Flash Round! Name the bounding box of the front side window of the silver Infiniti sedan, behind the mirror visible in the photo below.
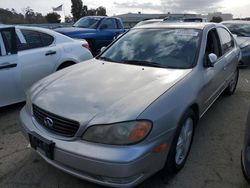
[205,29,221,62]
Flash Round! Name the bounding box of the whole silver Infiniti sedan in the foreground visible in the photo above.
[20,22,240,187]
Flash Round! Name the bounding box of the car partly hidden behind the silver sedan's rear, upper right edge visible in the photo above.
[222,20,250,67]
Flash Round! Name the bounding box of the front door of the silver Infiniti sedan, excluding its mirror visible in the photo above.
[201,28,226,112]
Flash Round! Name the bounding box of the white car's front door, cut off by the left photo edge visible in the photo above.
[0,27,25,107]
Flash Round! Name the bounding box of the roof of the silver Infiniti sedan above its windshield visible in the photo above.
[134,21,218,30]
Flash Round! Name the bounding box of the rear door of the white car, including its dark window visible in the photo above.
[17,28,60,91]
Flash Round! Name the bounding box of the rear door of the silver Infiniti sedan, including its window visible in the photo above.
[217,27,240,82]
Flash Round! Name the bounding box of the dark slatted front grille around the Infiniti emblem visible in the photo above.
[33,105,80,137]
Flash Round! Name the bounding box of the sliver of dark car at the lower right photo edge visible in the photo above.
[241,110,250,182]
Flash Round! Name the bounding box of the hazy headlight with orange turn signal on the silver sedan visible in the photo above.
[82,120,152,145]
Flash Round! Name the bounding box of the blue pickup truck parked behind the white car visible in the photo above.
[55,16,125,55]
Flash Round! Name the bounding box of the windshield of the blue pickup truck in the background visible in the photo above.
[73,17,101,29]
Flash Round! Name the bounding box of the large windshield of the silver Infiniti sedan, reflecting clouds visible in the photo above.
[99,29,200,69]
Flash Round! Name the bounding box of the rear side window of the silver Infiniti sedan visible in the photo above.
[217,28,234,54]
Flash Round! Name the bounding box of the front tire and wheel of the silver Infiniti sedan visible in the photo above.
[163,109,197,176]
